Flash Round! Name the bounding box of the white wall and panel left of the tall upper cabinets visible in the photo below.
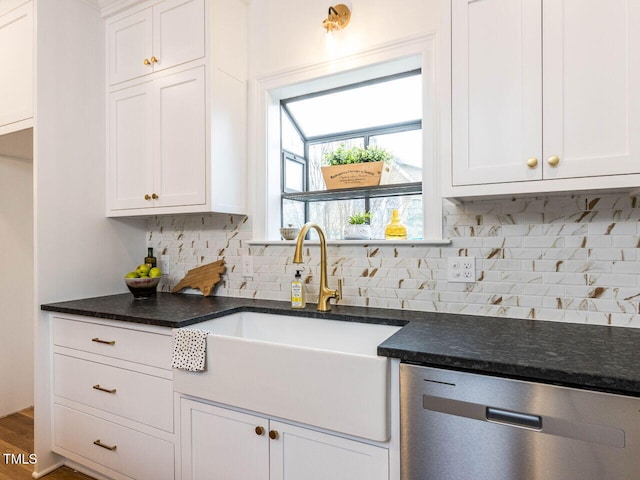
[34,0,146,472]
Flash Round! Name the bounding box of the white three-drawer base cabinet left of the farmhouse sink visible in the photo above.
[51,315,177,480]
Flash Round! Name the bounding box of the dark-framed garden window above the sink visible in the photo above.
[280,69,424,240]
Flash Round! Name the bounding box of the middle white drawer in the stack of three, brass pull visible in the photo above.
[54,354,173,432]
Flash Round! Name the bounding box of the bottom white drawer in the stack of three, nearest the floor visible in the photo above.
[53,405,175,480]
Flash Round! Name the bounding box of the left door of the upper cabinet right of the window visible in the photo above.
[451,0,542,185]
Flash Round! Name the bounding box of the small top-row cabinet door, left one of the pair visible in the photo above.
[107,9,153,85]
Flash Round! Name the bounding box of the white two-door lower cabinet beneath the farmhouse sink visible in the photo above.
[180,398,389,480]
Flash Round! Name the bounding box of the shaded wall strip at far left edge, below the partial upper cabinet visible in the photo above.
[0,153,33,417]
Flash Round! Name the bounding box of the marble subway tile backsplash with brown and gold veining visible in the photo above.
[147,193,640,327]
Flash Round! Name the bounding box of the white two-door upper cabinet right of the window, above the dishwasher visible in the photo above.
[443,0,640,197]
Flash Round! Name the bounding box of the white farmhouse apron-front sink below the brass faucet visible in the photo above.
[174,312,400,441]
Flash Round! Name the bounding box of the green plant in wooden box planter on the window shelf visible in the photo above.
[322,143,393,190]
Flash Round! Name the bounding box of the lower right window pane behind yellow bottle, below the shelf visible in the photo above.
[370,195,423,240]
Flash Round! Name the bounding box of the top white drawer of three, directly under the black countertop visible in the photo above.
[53,317,173,370]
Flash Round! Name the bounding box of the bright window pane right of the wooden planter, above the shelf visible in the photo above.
[369,130,422,183]
